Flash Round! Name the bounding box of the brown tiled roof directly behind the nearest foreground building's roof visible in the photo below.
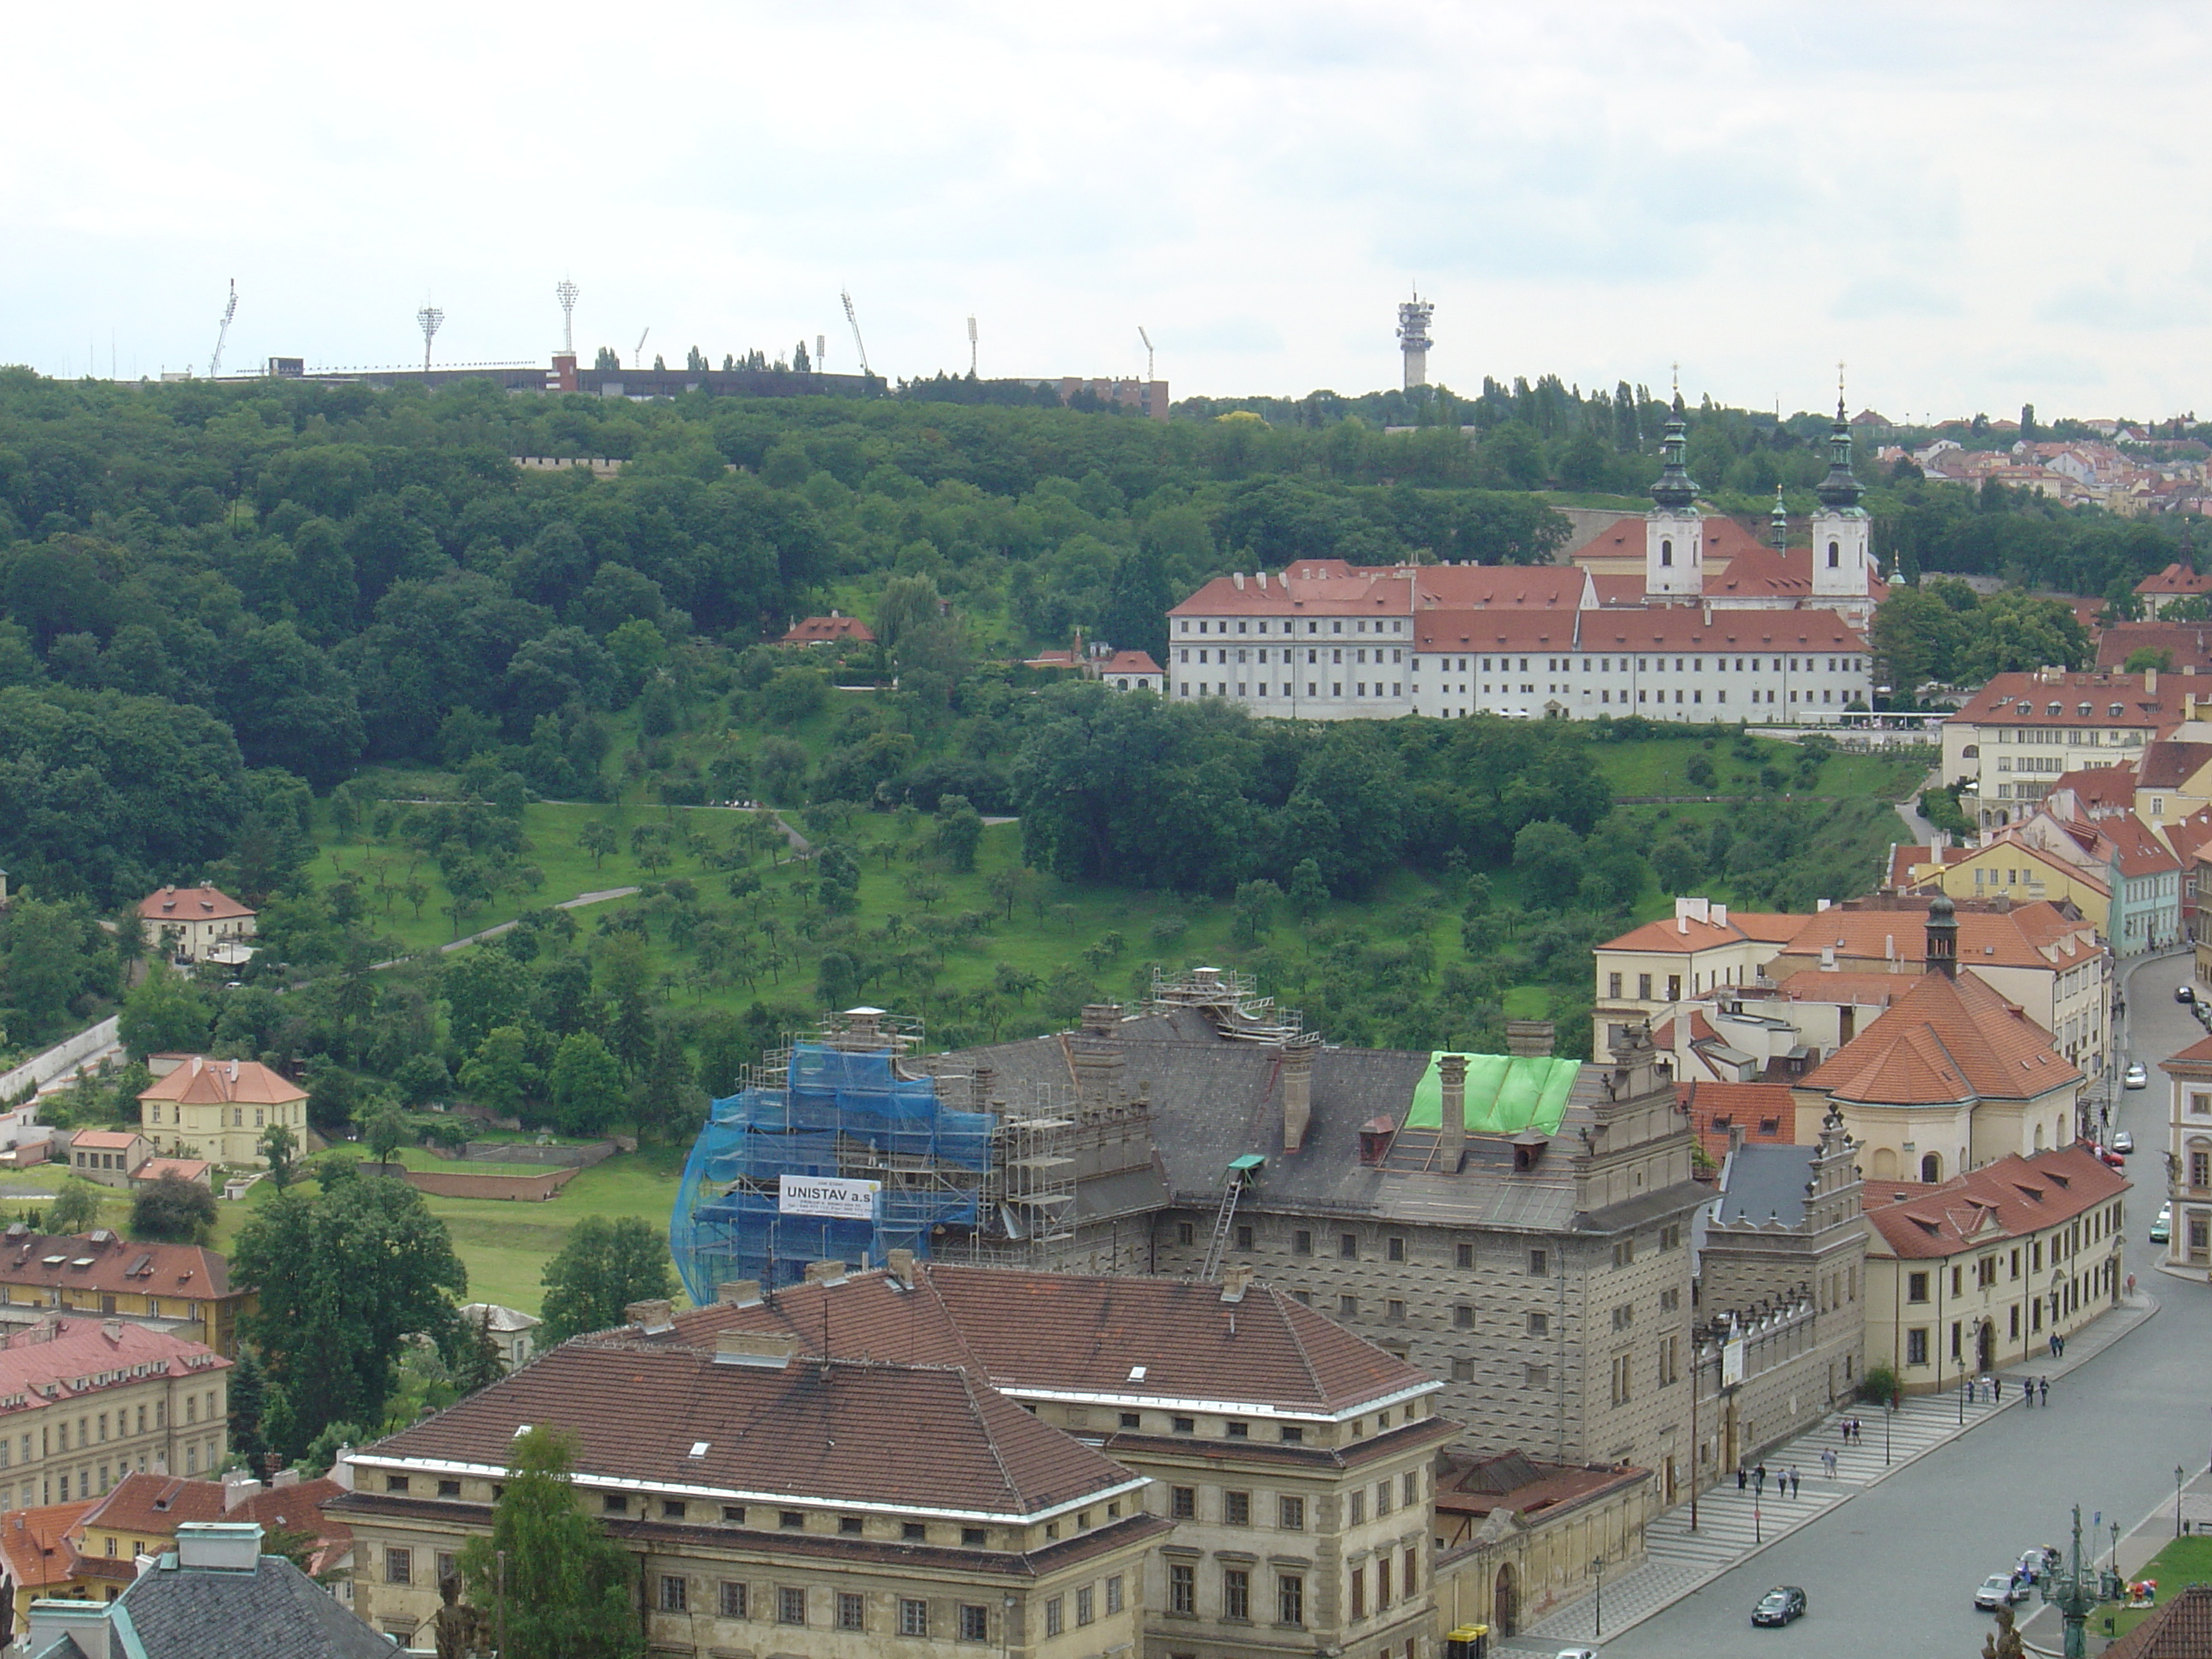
[614,1263,1434,1416]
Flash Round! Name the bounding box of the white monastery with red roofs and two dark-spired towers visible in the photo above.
[1166,399,1883,724]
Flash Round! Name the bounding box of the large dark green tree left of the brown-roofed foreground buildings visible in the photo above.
[230,1174,469,1458]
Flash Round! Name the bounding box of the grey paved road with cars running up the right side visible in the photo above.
[1575,958,2212,1659]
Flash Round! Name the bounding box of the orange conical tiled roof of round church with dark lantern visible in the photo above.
[1802,973,2081,1106]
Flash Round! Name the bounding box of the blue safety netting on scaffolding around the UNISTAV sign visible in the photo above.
[668,1042,993,1303]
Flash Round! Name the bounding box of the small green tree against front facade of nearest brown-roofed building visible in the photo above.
[460,1427,646,1659]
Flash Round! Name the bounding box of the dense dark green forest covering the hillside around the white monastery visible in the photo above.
[0,370,2179,1092]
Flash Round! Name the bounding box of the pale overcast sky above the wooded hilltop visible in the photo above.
[0,0,2212,418]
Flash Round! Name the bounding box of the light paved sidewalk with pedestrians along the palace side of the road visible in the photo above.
[1495,1289,2159,1655]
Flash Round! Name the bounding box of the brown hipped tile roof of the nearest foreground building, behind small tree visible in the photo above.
[360,1331,1132,1520]
